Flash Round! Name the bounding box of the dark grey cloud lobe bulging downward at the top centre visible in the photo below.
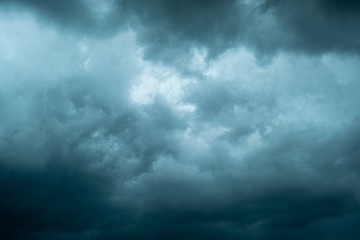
[118,0,248,62]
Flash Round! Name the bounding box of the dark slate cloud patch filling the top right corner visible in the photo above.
[266,0,360,54]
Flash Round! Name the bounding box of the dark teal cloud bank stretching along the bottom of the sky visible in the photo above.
[0,116,359,239]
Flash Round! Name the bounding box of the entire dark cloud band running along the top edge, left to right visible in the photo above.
[1,0,360,63]
